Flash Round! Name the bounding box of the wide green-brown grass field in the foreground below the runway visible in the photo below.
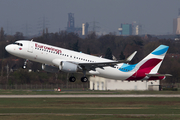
[0,98,180,120]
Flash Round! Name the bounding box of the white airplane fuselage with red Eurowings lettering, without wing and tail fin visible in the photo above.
[5,40,169,80]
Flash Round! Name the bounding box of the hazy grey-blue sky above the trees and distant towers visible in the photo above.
[0,0,180,35]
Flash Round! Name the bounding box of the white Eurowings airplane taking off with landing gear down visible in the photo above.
[5,40,171,82]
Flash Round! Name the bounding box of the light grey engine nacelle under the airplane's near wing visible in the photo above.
[59,61,78,73]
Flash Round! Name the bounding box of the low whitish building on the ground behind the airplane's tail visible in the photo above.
[89,76,160,91]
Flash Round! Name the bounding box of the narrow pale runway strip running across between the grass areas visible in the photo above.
[0,94,180,98]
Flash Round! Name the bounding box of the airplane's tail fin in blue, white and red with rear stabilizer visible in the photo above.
[127,45,169,80]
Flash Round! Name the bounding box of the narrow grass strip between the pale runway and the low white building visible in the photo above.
[0,89,180,95]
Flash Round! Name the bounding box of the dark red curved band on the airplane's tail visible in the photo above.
[127,58,162,80]
